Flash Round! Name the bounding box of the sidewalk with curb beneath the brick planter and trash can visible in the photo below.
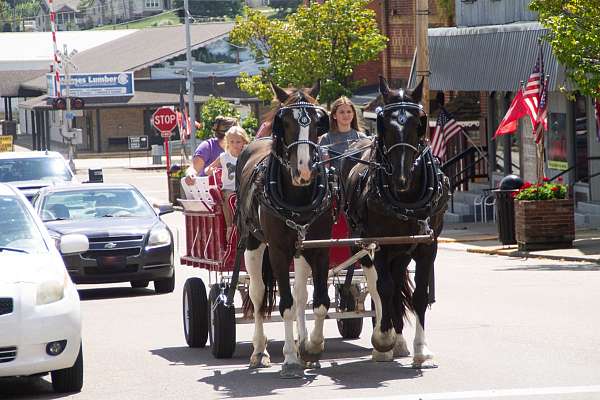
[439,223,600,264]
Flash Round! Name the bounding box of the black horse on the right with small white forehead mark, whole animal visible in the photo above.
[341,77,448,366]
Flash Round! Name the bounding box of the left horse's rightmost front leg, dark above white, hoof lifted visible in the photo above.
[299,249,330,367]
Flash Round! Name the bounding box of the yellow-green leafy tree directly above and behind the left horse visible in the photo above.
[230,0,387,103]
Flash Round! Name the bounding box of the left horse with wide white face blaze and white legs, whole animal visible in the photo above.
[236,83,333,378]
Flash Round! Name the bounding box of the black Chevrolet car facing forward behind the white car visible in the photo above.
[33,183,175,293]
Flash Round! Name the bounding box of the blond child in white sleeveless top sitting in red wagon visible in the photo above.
[204,125,250,239]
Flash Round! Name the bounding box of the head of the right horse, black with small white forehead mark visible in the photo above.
[377,76,427,193]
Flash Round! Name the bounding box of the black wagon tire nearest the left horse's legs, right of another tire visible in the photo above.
[208,284,236,358]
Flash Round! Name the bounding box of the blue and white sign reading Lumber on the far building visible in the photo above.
[46,72,134,98]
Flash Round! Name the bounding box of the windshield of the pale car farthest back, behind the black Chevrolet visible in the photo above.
[0,157,73,182]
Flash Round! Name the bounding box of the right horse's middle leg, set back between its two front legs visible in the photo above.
[392,254,412,357]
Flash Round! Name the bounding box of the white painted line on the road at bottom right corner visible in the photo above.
[344,385,600,400]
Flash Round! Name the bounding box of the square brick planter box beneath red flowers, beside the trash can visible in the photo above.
[515,199,575,251]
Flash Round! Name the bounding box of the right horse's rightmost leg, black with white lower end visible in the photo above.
[412,242,437,367]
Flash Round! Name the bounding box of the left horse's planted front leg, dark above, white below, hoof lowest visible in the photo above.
[269,246,304,378]
